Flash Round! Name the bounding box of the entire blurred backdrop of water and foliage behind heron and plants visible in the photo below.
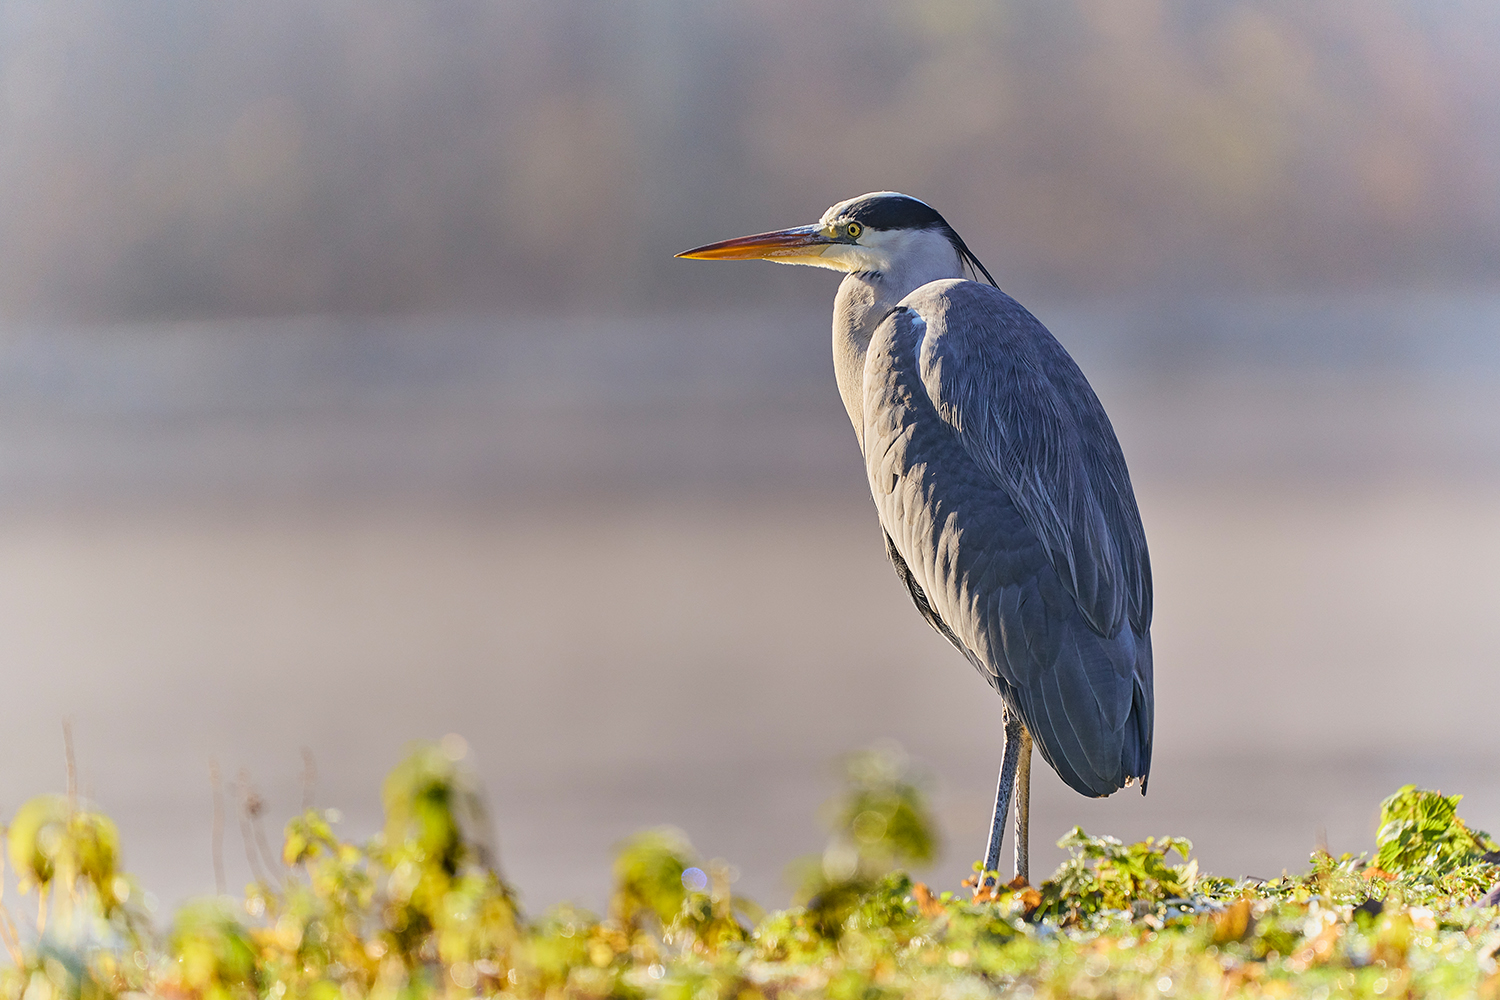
[0,0,1500,910]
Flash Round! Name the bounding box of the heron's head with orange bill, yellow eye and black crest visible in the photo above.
[678,190,995,285]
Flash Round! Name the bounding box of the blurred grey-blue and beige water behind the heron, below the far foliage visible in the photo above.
[0,295,1500,906]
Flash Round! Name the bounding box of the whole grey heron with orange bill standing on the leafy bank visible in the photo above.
[678,192,1155,886]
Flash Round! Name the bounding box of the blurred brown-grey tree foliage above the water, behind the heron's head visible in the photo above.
[0,0,1500,318]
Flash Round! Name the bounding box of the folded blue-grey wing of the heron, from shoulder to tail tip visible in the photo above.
[864,282,1154,795]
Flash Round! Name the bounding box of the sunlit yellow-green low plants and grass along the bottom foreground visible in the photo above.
[0,747,1500,1000]
